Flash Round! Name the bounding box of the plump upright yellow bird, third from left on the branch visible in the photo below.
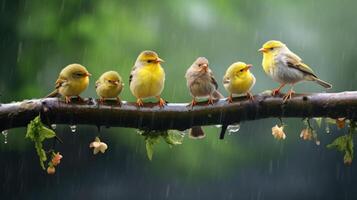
[129,51,166,107]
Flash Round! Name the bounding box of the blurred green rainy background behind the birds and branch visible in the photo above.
[0,0,357,199]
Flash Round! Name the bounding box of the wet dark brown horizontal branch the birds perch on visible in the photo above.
[0,92,357,130]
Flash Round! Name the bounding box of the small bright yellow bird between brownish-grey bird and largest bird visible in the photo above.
[223,62,255,103]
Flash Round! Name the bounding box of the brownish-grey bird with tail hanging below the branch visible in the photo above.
[185,57,224,138]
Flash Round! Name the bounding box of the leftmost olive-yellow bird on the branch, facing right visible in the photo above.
[46,64,91,103]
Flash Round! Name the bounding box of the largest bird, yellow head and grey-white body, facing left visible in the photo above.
[259,40,332,101]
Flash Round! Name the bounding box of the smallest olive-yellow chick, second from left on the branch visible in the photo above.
[95,71,124,104]
